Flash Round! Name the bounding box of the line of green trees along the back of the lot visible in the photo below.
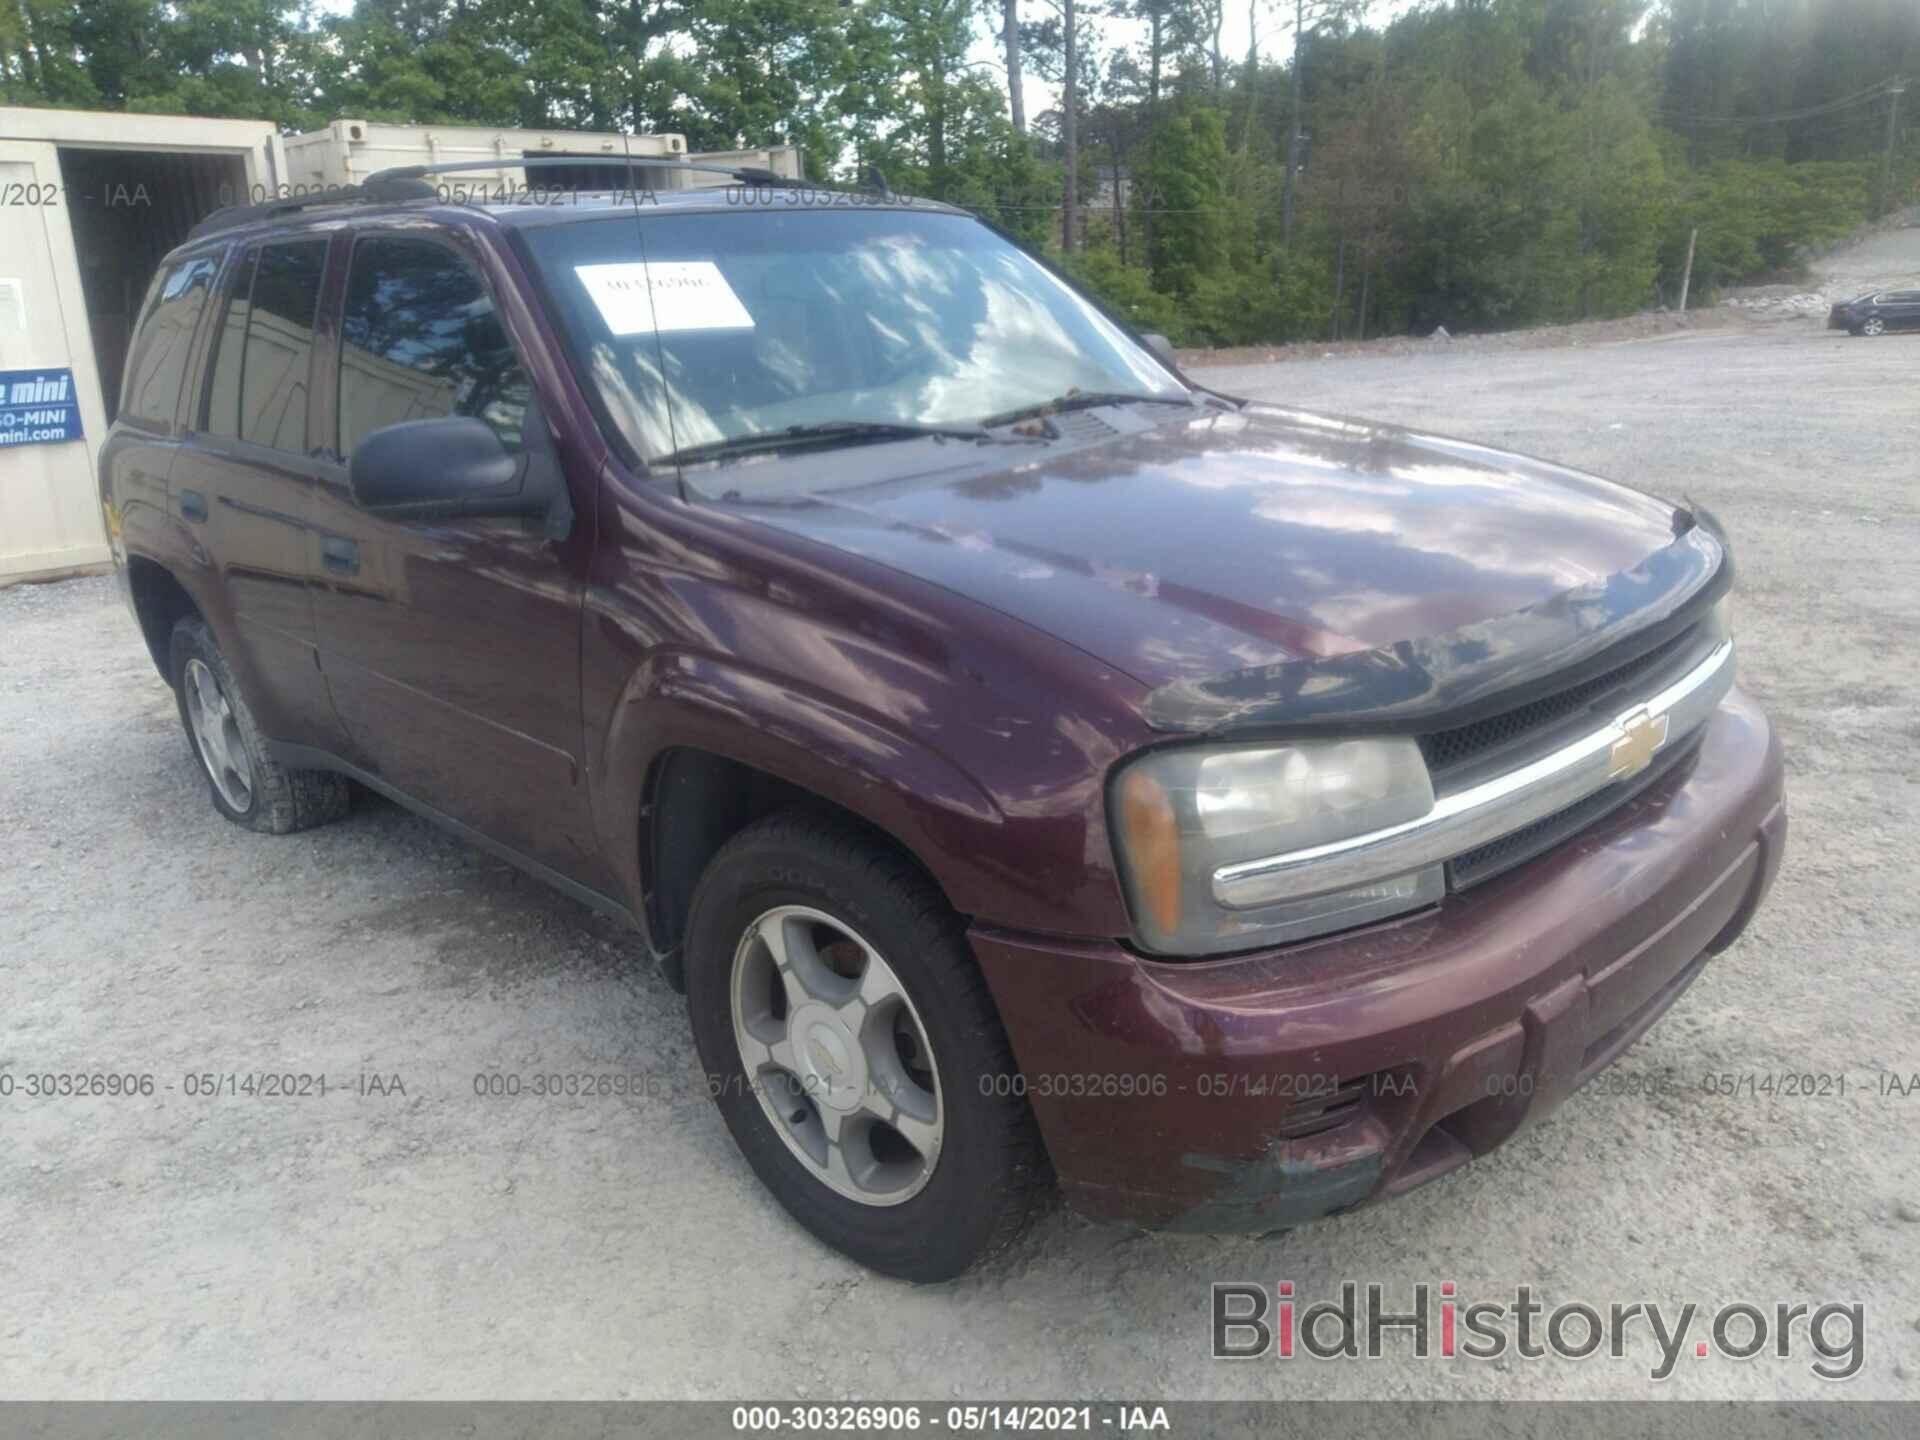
[0,0,1920,344]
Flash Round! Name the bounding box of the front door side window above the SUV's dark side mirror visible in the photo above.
[340,236,532,455]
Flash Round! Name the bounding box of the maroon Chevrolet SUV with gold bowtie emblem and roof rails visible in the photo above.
[102,175,1786,1279]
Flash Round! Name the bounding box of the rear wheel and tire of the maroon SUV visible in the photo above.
[169,616,349,835]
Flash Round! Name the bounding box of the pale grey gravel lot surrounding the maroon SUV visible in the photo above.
[0,230,1920,1400]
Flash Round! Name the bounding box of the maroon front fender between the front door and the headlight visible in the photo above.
[582,467,1148,952]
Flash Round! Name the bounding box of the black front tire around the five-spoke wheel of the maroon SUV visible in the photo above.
[687,810,1052,1283]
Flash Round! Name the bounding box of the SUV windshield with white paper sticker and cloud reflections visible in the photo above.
[526,209,1188,461]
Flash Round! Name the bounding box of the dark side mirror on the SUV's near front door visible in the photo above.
[348,415,570,520]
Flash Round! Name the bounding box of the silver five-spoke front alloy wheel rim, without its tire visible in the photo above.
[730,904,945,1206]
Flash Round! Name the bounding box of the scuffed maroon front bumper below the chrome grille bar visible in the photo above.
[972,689,1786,1231]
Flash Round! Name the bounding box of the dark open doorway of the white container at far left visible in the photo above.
[60,146,248,424]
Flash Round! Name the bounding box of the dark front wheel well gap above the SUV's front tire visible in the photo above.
[641,747,956,989]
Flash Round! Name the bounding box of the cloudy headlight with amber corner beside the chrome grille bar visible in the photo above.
[1112,739,1446,954]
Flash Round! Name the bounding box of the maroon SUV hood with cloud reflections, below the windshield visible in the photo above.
[725,405,1718,725]
